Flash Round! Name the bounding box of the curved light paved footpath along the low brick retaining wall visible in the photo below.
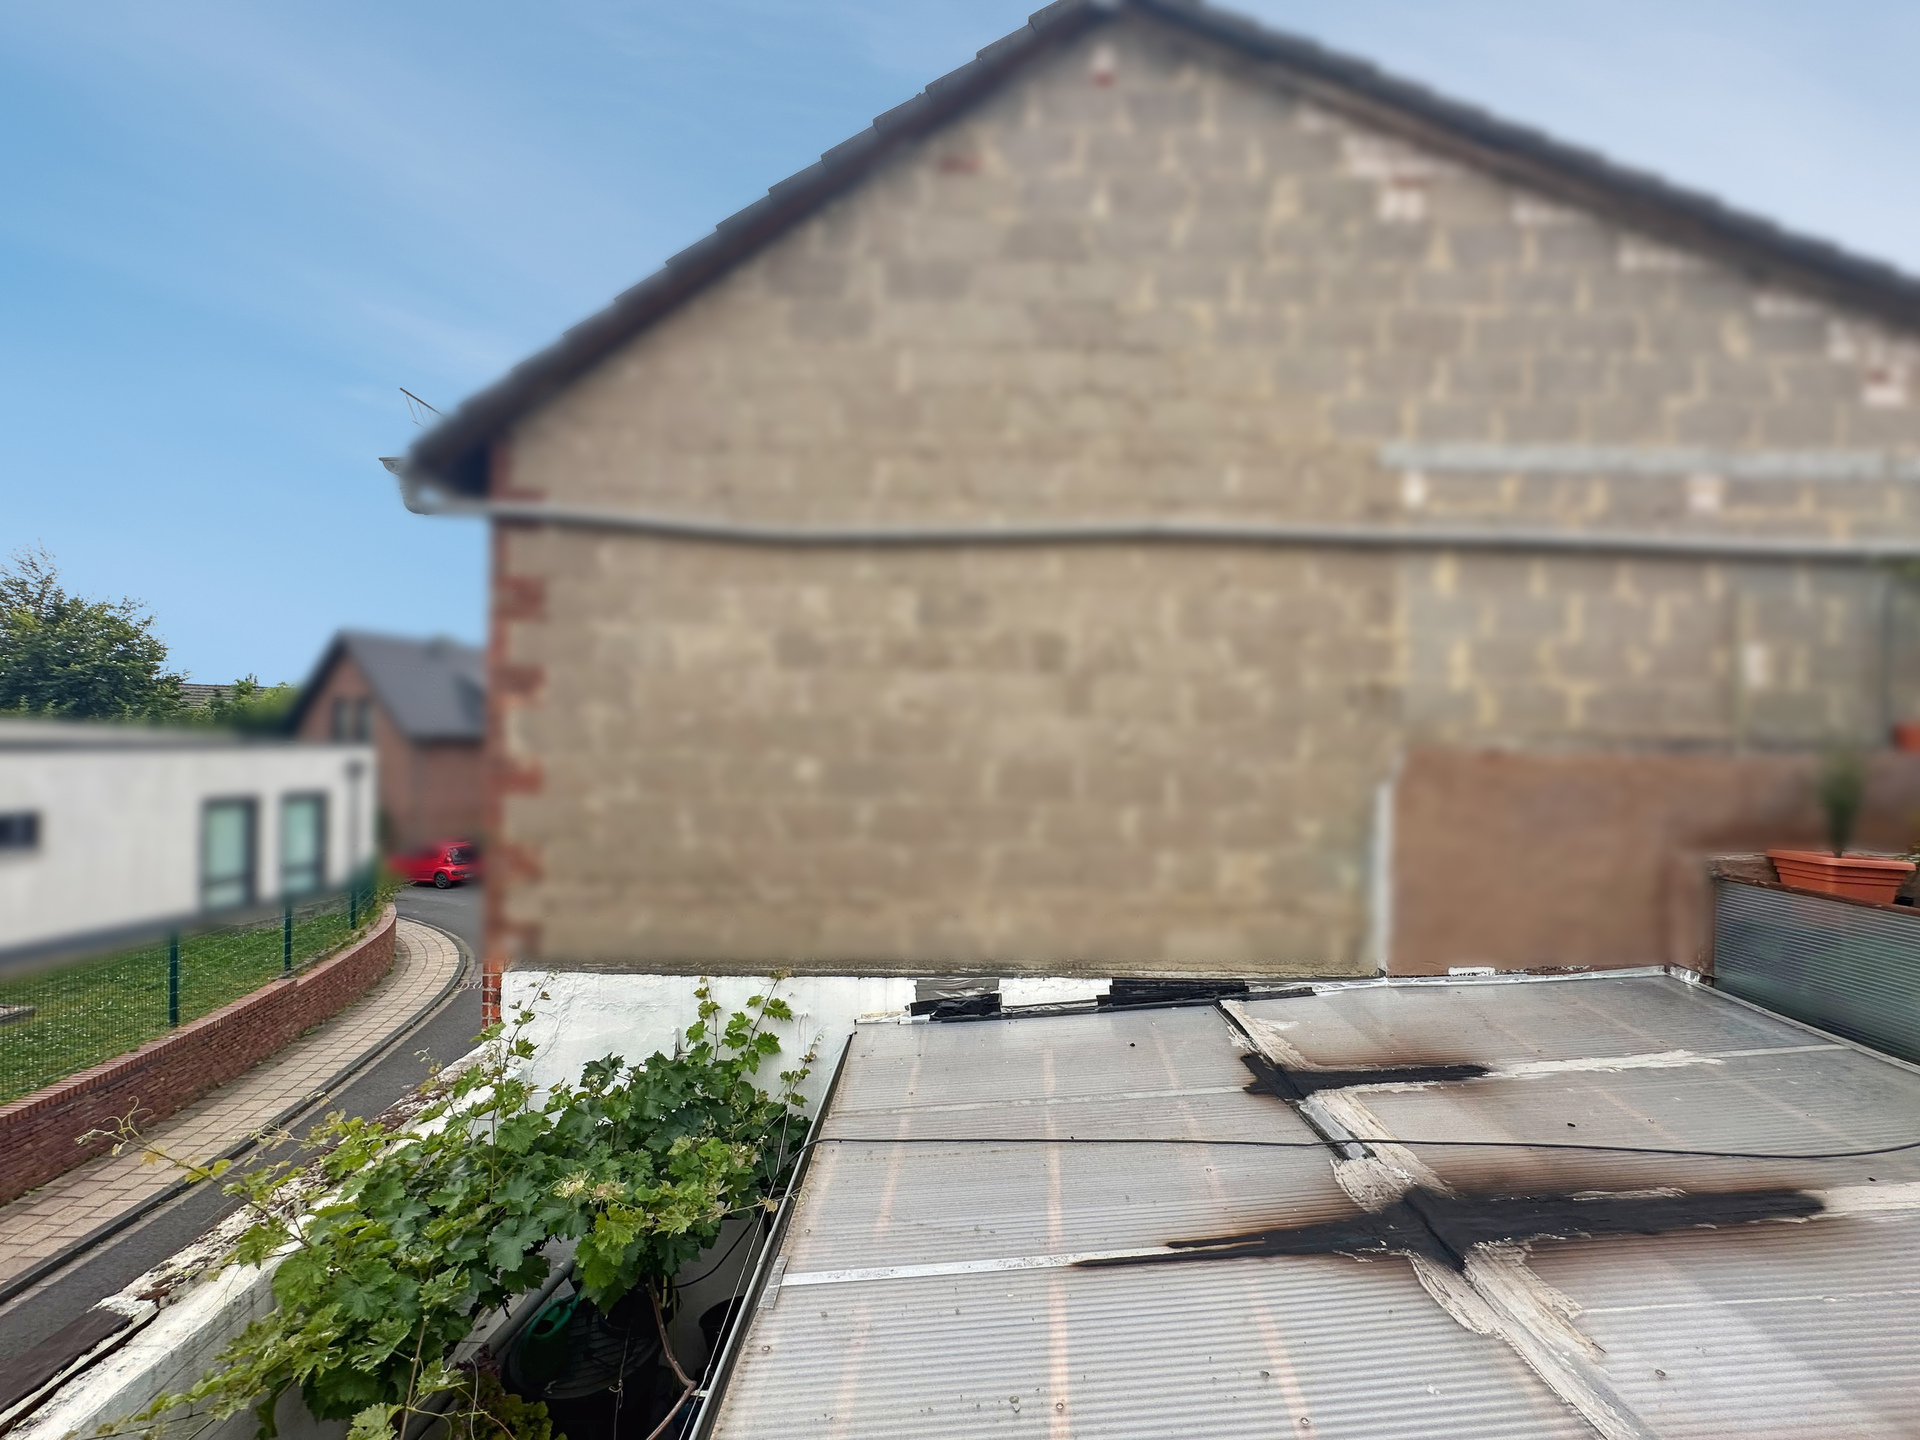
[0,920,461,1286]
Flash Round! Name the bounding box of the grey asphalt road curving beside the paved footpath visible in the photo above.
[0,885,480,1359]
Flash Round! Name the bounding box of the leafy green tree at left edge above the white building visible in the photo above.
[0,547,180,720]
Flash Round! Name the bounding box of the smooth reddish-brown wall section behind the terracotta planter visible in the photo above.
[1388,747,1920,975]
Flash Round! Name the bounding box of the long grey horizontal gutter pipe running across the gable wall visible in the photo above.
[384,474,1920,564]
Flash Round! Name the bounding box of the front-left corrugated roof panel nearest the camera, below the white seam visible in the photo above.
[714,1256,1588,1440]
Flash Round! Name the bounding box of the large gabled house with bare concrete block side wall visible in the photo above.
[407,0,1920,1013]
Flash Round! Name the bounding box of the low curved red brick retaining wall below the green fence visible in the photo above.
[0,906,397,1204]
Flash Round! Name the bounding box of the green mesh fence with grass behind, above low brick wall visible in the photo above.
[0,877,392,1104]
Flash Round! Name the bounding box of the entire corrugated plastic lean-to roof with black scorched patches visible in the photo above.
[708,977,1920,1440]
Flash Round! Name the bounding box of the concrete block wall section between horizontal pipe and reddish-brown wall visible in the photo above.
[1400,555,1881,747]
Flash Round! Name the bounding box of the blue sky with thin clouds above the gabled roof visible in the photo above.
[0,0,1920,680]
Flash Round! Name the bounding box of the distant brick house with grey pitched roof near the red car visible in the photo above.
[288,630,486,851]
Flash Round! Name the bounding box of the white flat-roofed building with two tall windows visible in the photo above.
[0,720,376,958]
